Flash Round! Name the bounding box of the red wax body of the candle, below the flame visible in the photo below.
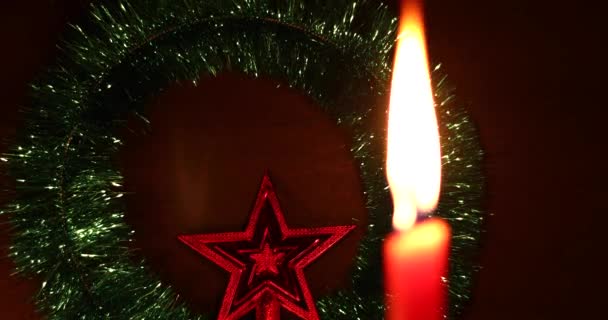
[384,219,450,320]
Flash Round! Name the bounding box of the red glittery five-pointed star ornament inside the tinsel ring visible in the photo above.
[178,174,355,320]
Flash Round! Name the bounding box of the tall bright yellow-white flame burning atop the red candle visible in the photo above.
[386,0,441,230]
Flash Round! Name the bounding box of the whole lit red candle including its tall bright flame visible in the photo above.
[384,0,450,320]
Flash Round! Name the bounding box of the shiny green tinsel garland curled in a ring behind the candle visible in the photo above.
[0,0,482,319]
